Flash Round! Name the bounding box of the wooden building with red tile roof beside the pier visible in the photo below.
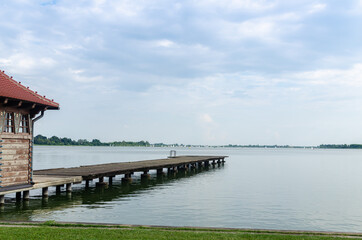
[0,71,59,192]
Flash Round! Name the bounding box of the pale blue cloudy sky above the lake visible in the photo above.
[0,0,362,145]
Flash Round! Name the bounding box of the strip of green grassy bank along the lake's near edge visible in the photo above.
[0,222,362,240]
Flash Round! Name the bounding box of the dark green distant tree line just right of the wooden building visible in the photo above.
[34,135,151,147]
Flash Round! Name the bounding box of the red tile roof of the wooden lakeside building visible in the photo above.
[0,70,59,109]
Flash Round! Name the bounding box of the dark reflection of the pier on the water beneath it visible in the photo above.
[0,164,224,221]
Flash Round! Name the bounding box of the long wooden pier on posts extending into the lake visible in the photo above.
[0,156,227,205]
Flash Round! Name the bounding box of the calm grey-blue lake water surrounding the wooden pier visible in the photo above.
[0,146,362,232]
